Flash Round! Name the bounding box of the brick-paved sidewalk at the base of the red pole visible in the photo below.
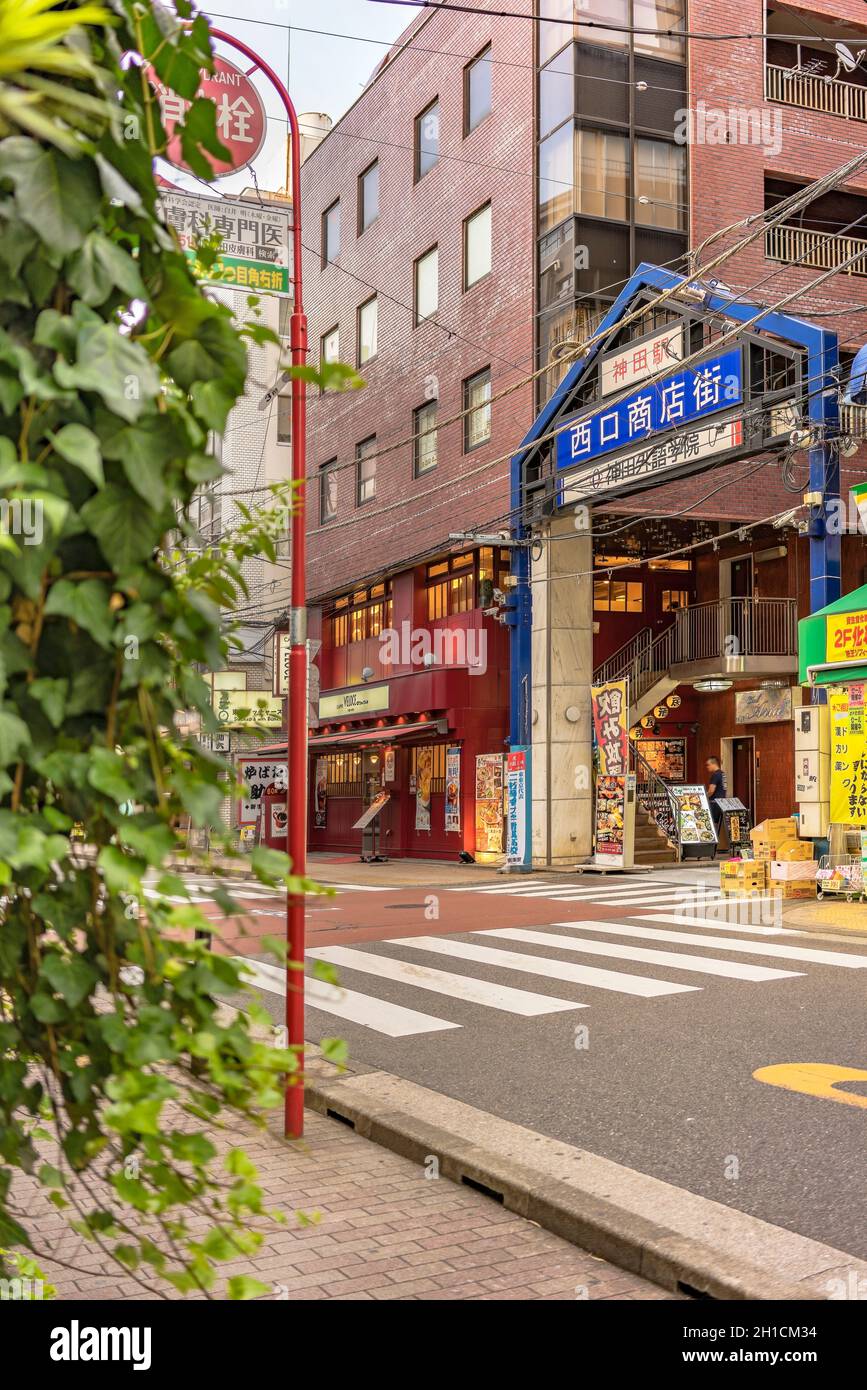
[14,1111,675,1301]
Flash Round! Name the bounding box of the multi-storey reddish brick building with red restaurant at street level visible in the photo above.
[284,0,867,863]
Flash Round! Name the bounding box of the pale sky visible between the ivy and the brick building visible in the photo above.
[177,0,418,195]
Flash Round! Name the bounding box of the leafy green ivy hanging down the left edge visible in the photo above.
[0,0,343,1297]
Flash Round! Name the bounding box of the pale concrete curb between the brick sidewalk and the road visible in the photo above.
[297,1048,867,1302]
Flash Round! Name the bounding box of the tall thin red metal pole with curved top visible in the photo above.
[211,29,307,1138]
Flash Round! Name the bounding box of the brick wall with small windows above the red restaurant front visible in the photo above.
[302,0,535,599]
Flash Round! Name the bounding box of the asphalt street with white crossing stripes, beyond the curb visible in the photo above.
[184,874,867,1258]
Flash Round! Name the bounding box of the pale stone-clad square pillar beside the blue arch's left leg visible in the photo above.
[531,512,593,867]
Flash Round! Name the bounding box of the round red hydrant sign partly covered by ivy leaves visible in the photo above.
[149,58,267,178]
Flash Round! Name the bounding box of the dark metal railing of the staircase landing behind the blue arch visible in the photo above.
[597,598,798,705]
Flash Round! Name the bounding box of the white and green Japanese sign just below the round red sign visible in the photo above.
[160,192,290,295]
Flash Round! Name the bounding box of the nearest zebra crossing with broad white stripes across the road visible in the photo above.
[233,909,867,1038]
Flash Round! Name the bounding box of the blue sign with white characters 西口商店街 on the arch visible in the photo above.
[557,348,743,468]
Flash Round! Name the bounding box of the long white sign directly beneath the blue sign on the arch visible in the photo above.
[560,420,743,506]
